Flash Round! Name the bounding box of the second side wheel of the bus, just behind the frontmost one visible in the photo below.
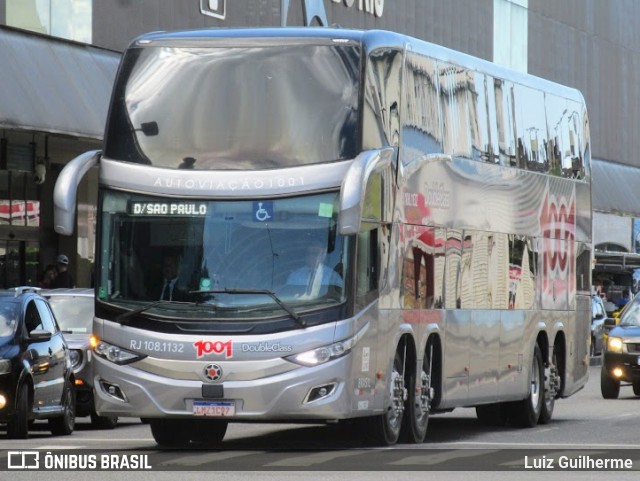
[401,347,432,443]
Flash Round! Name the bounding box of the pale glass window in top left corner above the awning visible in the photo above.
[6,0,93,43]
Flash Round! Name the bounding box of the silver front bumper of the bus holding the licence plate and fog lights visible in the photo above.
[94,354,370,421]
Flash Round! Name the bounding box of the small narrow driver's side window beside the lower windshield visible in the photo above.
[356,229,380,308]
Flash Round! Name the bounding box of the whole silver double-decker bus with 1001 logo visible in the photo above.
[54,28,592,446]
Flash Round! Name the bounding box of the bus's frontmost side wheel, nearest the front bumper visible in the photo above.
[363,351,407,446]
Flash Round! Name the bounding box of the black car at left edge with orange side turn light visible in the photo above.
[0,288,75,438]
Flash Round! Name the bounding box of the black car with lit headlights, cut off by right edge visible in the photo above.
[600,296,640,399]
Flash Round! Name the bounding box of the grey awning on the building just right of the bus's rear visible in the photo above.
[591,159,640,217]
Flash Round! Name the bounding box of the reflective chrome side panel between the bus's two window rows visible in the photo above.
[397,155,591,241]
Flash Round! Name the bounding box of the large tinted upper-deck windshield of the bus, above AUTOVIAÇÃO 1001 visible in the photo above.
[104,43,360,170]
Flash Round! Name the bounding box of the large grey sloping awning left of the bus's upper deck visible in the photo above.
[0,27,121,139]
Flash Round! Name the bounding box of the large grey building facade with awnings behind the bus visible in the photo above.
[0,0,640,287]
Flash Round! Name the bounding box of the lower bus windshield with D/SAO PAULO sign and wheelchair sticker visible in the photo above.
[97,190,348,320]
